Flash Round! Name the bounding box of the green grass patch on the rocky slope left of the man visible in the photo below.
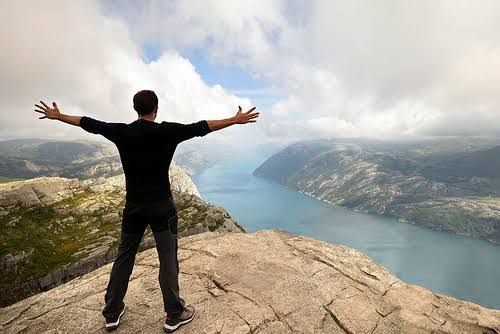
[0,189,121,279]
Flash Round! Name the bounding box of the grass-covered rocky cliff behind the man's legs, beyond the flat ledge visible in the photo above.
[0,163,243,306]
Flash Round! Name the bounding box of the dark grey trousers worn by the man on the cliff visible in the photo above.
[102,203,185,319]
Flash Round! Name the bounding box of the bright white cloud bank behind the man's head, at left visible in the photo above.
[0,1,251,141]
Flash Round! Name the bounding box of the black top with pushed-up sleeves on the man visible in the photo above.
[80,116,211,203]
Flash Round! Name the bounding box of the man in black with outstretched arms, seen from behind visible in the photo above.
[35,90,259,333]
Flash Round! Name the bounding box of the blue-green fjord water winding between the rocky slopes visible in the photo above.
[192,153,500,309]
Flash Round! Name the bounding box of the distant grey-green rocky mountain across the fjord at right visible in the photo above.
[253,139,500,242]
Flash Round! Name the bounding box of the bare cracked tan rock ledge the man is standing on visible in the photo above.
[0,230,500,334]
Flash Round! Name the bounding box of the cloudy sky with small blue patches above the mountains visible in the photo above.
[0,0,500,147]
